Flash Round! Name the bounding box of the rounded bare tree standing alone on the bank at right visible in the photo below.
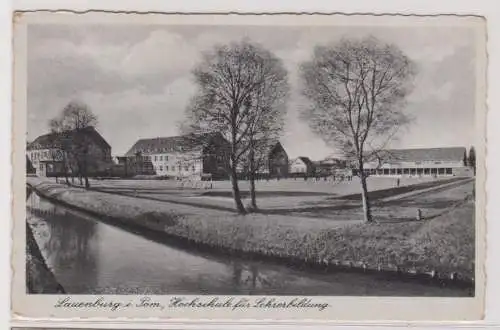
[301,37,415,222]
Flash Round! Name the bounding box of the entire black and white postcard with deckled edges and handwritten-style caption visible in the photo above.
[12,12,487,321]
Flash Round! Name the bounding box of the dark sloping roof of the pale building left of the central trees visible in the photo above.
[125,132,224,156]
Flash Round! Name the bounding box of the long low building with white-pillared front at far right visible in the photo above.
[353,147,473,177]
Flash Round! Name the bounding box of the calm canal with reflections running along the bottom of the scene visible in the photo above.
[27,193,469,296]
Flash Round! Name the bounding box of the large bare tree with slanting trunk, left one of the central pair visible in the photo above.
[182,40,286,213]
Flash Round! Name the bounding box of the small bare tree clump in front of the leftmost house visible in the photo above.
[49,101,97,188]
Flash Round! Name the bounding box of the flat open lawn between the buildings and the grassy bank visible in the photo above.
[51,177,464,214]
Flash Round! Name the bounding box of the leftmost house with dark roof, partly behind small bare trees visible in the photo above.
[26,126,112,176]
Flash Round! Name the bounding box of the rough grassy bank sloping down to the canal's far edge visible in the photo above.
[28,178,474,283]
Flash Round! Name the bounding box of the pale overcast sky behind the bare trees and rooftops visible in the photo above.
[28,25,475,160]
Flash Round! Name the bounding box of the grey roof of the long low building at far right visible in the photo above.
[379,147,466,162]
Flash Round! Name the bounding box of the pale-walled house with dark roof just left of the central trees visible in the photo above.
[118,132,229,179]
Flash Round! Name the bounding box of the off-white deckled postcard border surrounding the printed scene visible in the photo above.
[12,12,486,321]
